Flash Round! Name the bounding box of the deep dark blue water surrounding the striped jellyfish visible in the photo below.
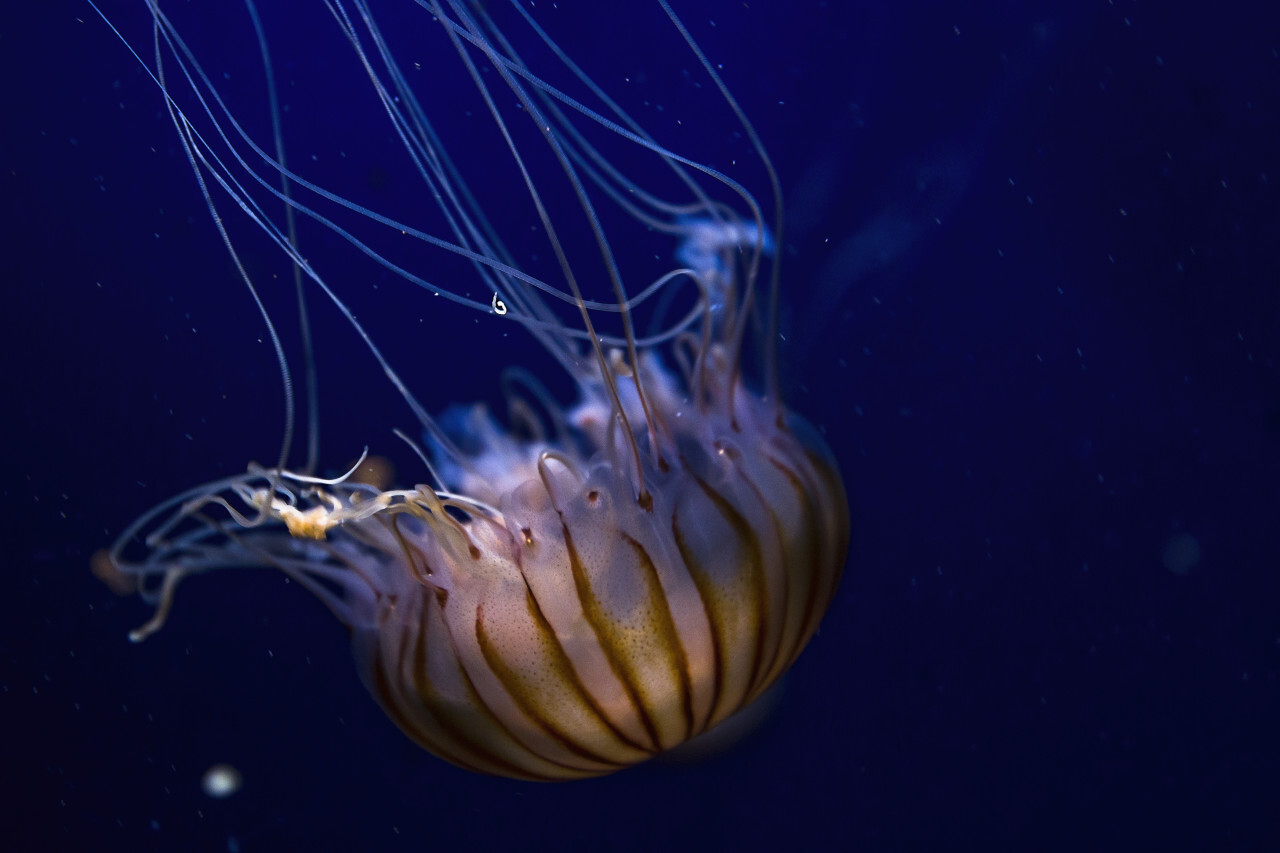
[0,0,1280,850]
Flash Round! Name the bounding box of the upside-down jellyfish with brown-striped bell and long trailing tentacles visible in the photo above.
[95,0,849,780]
